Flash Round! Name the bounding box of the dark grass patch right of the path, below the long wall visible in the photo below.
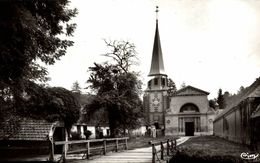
[170,136,260,163]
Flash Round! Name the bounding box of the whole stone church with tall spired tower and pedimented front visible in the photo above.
[143,8,215,136]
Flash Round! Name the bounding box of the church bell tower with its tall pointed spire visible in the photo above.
[144,6,169,136]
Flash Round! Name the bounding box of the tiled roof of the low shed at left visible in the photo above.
[0,119,61,140]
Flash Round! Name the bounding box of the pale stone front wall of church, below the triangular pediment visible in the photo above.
[165,95,215,135]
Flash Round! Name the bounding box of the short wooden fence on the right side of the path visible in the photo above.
[149,139,177,163]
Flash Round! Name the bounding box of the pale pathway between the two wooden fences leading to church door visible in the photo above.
[67,137,189,163]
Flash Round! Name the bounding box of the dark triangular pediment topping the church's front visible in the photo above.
[173,85,209,96]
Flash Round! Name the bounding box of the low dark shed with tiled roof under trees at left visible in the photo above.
[0,118,65,162]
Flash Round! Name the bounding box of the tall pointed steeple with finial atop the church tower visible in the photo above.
[148,6,167,76]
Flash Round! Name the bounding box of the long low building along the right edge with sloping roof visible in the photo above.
[213,78,260,149]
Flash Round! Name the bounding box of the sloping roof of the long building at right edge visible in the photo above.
[215,77,260,120]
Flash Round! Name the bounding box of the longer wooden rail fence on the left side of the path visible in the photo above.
[50,137,129,162]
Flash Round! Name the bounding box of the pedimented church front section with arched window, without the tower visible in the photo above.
[165,86,215,136]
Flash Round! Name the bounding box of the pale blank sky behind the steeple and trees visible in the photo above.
[48,0,260,99]
